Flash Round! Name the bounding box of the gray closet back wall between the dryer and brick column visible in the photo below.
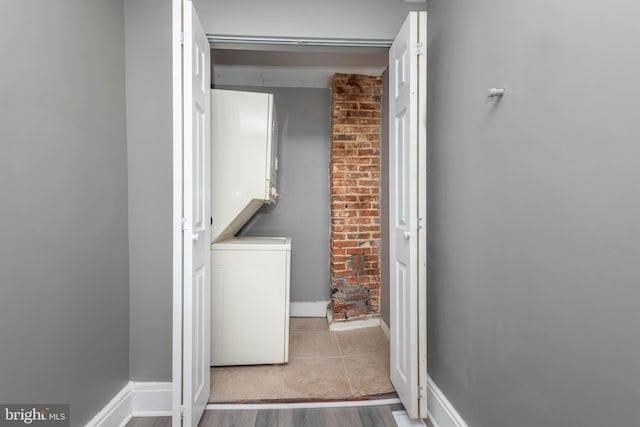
[221,87,331,302]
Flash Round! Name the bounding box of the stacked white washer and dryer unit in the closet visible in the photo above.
[211,89,291,366]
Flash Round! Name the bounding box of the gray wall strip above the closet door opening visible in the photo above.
[194,0,426,40]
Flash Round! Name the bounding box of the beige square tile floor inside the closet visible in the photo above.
[210,317,395,403]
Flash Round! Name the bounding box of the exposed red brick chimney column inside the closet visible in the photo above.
[329,74,382,320]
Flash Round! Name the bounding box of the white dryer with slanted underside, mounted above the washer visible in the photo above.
[211,89,278,242]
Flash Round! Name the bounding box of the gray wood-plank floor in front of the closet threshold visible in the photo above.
[127,404,432,427]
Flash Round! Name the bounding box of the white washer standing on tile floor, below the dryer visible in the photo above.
[211,237,291,366]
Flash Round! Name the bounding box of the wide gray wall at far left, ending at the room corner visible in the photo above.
[0,0,129,425]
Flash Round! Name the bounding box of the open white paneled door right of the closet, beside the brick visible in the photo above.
[389,12,427,419]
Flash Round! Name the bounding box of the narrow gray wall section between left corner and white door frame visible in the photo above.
[125,0,172,381]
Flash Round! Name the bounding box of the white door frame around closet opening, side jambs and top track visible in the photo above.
[171,0,428,427]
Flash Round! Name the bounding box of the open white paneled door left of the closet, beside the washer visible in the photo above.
[173,0,211,427]
